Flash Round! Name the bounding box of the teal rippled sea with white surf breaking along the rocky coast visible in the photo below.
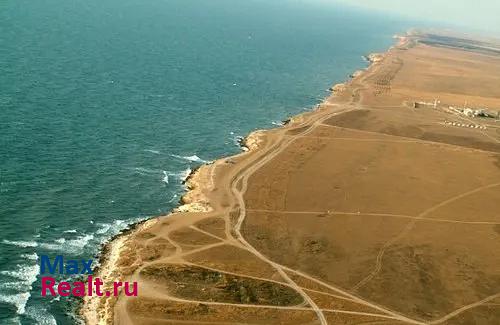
[0,0,415,325]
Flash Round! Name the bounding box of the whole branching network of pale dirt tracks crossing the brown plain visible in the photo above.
[101,36,500,325]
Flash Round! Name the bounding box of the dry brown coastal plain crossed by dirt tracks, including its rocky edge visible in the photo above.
[82,34,500,324]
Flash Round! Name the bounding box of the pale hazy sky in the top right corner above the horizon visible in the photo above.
[332,0,500,36]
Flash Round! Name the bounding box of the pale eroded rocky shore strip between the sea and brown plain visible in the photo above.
[79,36,406,324]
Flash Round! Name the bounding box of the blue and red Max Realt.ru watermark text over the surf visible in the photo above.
[40,255,138,297]
